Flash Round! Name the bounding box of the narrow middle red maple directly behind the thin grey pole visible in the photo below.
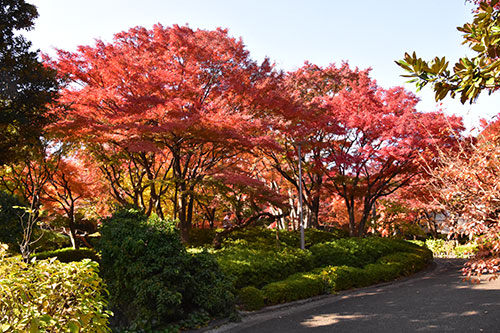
[265,62,361,228]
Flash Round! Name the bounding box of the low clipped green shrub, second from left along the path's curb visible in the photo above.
[262,272,326,305]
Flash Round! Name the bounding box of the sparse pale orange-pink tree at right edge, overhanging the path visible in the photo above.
[424,132,500,277]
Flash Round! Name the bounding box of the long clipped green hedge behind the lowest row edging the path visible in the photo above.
[214,238,432,289]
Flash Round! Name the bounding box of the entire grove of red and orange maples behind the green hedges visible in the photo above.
[0,24,470,252]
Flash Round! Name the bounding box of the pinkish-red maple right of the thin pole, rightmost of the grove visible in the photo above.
[325,72,462,236]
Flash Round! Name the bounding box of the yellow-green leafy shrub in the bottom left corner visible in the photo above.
[0,243,111,332]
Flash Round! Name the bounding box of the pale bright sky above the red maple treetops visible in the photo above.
[25,0,500,128]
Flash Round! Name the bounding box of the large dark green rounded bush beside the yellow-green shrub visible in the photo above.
[99,210,234,329]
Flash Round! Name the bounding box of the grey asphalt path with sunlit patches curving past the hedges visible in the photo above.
[210,259,500,333]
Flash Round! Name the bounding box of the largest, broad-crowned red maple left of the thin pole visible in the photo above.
[50,25,277,240]
